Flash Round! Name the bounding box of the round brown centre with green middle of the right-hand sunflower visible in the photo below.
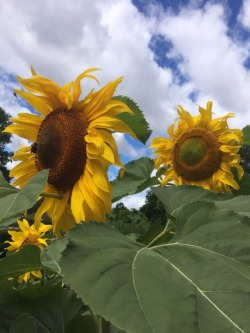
[173,127,222,181]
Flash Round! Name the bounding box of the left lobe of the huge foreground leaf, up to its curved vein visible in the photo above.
[61,223,150,333]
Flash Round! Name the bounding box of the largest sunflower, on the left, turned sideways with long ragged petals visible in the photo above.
[6,68,135,235]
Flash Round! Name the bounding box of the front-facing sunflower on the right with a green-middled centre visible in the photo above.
[150,102,244,192]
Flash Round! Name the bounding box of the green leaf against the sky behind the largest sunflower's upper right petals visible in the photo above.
[113,96,152,144]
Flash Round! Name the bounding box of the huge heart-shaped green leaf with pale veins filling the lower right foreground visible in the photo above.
[61,206,250,333]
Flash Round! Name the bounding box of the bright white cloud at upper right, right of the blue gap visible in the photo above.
[156,4,250,126]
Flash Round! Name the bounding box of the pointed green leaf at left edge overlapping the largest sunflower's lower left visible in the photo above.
[0,170,48,226]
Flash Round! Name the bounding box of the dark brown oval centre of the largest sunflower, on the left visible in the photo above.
[31,108,88,191]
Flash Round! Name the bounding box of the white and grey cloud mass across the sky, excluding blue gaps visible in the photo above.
[0,0,250,136]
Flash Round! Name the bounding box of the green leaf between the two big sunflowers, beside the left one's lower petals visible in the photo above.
[111,157,159,202]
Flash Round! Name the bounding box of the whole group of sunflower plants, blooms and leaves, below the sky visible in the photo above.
[0,68,250,333]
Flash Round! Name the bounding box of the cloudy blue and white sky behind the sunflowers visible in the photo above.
[0,0,250,208]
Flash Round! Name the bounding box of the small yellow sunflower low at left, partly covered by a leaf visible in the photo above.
[5,219,52,283]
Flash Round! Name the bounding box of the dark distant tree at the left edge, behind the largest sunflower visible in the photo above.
[0,107,13,181]
